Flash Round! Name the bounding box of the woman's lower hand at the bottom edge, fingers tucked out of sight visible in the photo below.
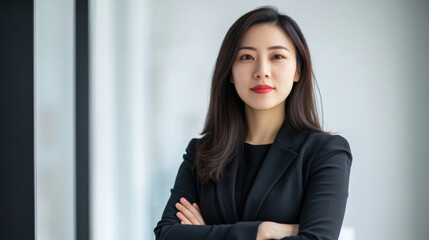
[256,222,299,240]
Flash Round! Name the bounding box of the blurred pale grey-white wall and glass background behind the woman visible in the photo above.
[34,0,429,240]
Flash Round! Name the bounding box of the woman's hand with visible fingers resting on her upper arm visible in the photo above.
[176,197,206,225]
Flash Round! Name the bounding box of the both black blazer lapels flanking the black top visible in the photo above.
[216,122,305,223]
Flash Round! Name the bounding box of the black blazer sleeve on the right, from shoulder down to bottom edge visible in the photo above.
[282,135,352,240]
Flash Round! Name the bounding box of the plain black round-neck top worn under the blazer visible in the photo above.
[235,142,272,220]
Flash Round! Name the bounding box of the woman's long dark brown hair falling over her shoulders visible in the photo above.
[194,7,323,184]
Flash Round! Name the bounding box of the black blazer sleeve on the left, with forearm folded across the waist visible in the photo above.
[154,139,262,240]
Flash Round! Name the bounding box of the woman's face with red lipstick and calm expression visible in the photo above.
[231,24,299,110]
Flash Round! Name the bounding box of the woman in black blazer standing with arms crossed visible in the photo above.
[154,7,352,240]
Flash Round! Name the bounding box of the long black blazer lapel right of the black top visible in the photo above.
[243,123,302,221]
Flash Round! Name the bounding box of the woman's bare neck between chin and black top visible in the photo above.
[245,102,285,145]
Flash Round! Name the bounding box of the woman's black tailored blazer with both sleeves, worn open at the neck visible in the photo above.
[154,123,352,240]
